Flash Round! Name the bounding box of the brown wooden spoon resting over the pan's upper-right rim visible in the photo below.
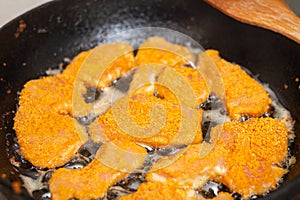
[205,0,300,44]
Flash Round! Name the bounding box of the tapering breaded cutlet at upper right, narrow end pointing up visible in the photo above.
[206,50,272,120]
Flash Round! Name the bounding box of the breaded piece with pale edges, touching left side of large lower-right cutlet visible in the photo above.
[146,141,227,189]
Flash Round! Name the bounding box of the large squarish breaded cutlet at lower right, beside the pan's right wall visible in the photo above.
[218,118,288,197]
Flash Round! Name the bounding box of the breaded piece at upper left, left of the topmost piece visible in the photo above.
[63,42,136,88]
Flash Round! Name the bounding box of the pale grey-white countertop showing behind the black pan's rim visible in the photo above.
[0,0,300,27]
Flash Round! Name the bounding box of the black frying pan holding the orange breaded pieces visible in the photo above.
[0,0,300,199]
